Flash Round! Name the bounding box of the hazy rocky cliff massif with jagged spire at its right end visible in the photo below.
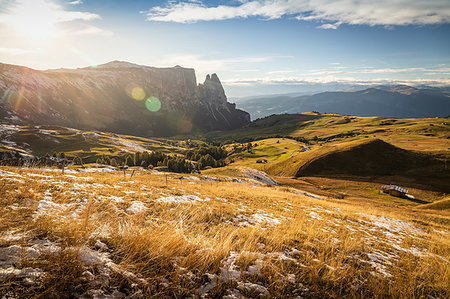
[0,61,250,136]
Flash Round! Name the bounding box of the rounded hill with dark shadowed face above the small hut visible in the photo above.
[266,138,450,192]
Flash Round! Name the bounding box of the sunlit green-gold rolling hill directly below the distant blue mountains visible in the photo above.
[206,113,450,152]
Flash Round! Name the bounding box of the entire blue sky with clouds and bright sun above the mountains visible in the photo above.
[0,0,450,97]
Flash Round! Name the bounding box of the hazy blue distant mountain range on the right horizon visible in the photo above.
[237,85,450,119]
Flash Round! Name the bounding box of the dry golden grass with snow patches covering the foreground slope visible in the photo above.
[0,167,450,298]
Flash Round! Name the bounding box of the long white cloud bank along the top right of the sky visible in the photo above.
[143,0,450,29]
